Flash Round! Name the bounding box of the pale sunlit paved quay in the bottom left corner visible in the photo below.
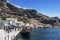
[0,29,20,40]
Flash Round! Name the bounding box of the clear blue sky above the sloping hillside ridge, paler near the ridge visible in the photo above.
[8,0,60,18]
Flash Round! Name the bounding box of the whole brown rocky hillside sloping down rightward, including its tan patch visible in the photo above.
[0,2,60,26]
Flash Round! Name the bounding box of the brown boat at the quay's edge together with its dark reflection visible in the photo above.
[20,26,30,39]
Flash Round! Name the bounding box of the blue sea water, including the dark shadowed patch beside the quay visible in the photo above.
[19,28,60,40]
